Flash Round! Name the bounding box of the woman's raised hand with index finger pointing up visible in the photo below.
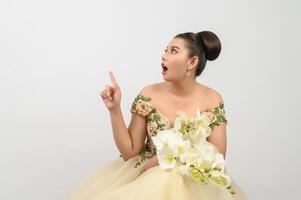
[100,70,121,111]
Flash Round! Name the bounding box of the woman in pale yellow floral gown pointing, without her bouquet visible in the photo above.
[66,31,246,200]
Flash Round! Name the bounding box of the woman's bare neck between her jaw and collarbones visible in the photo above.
[165,77,197,97]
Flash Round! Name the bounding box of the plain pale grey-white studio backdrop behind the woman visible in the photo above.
[0,0,301,200]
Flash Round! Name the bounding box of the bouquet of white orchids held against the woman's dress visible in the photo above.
[152,110,235,194]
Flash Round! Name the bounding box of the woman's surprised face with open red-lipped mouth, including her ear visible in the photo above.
[161,38,197,81]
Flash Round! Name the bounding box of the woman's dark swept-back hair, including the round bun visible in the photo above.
[174,31,221,76]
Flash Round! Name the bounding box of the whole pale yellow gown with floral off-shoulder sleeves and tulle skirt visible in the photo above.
[65,94,247,200]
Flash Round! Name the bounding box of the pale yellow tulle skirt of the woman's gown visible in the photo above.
[65,155,247,200]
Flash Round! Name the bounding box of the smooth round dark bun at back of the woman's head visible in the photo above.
[197,31,221,61]
